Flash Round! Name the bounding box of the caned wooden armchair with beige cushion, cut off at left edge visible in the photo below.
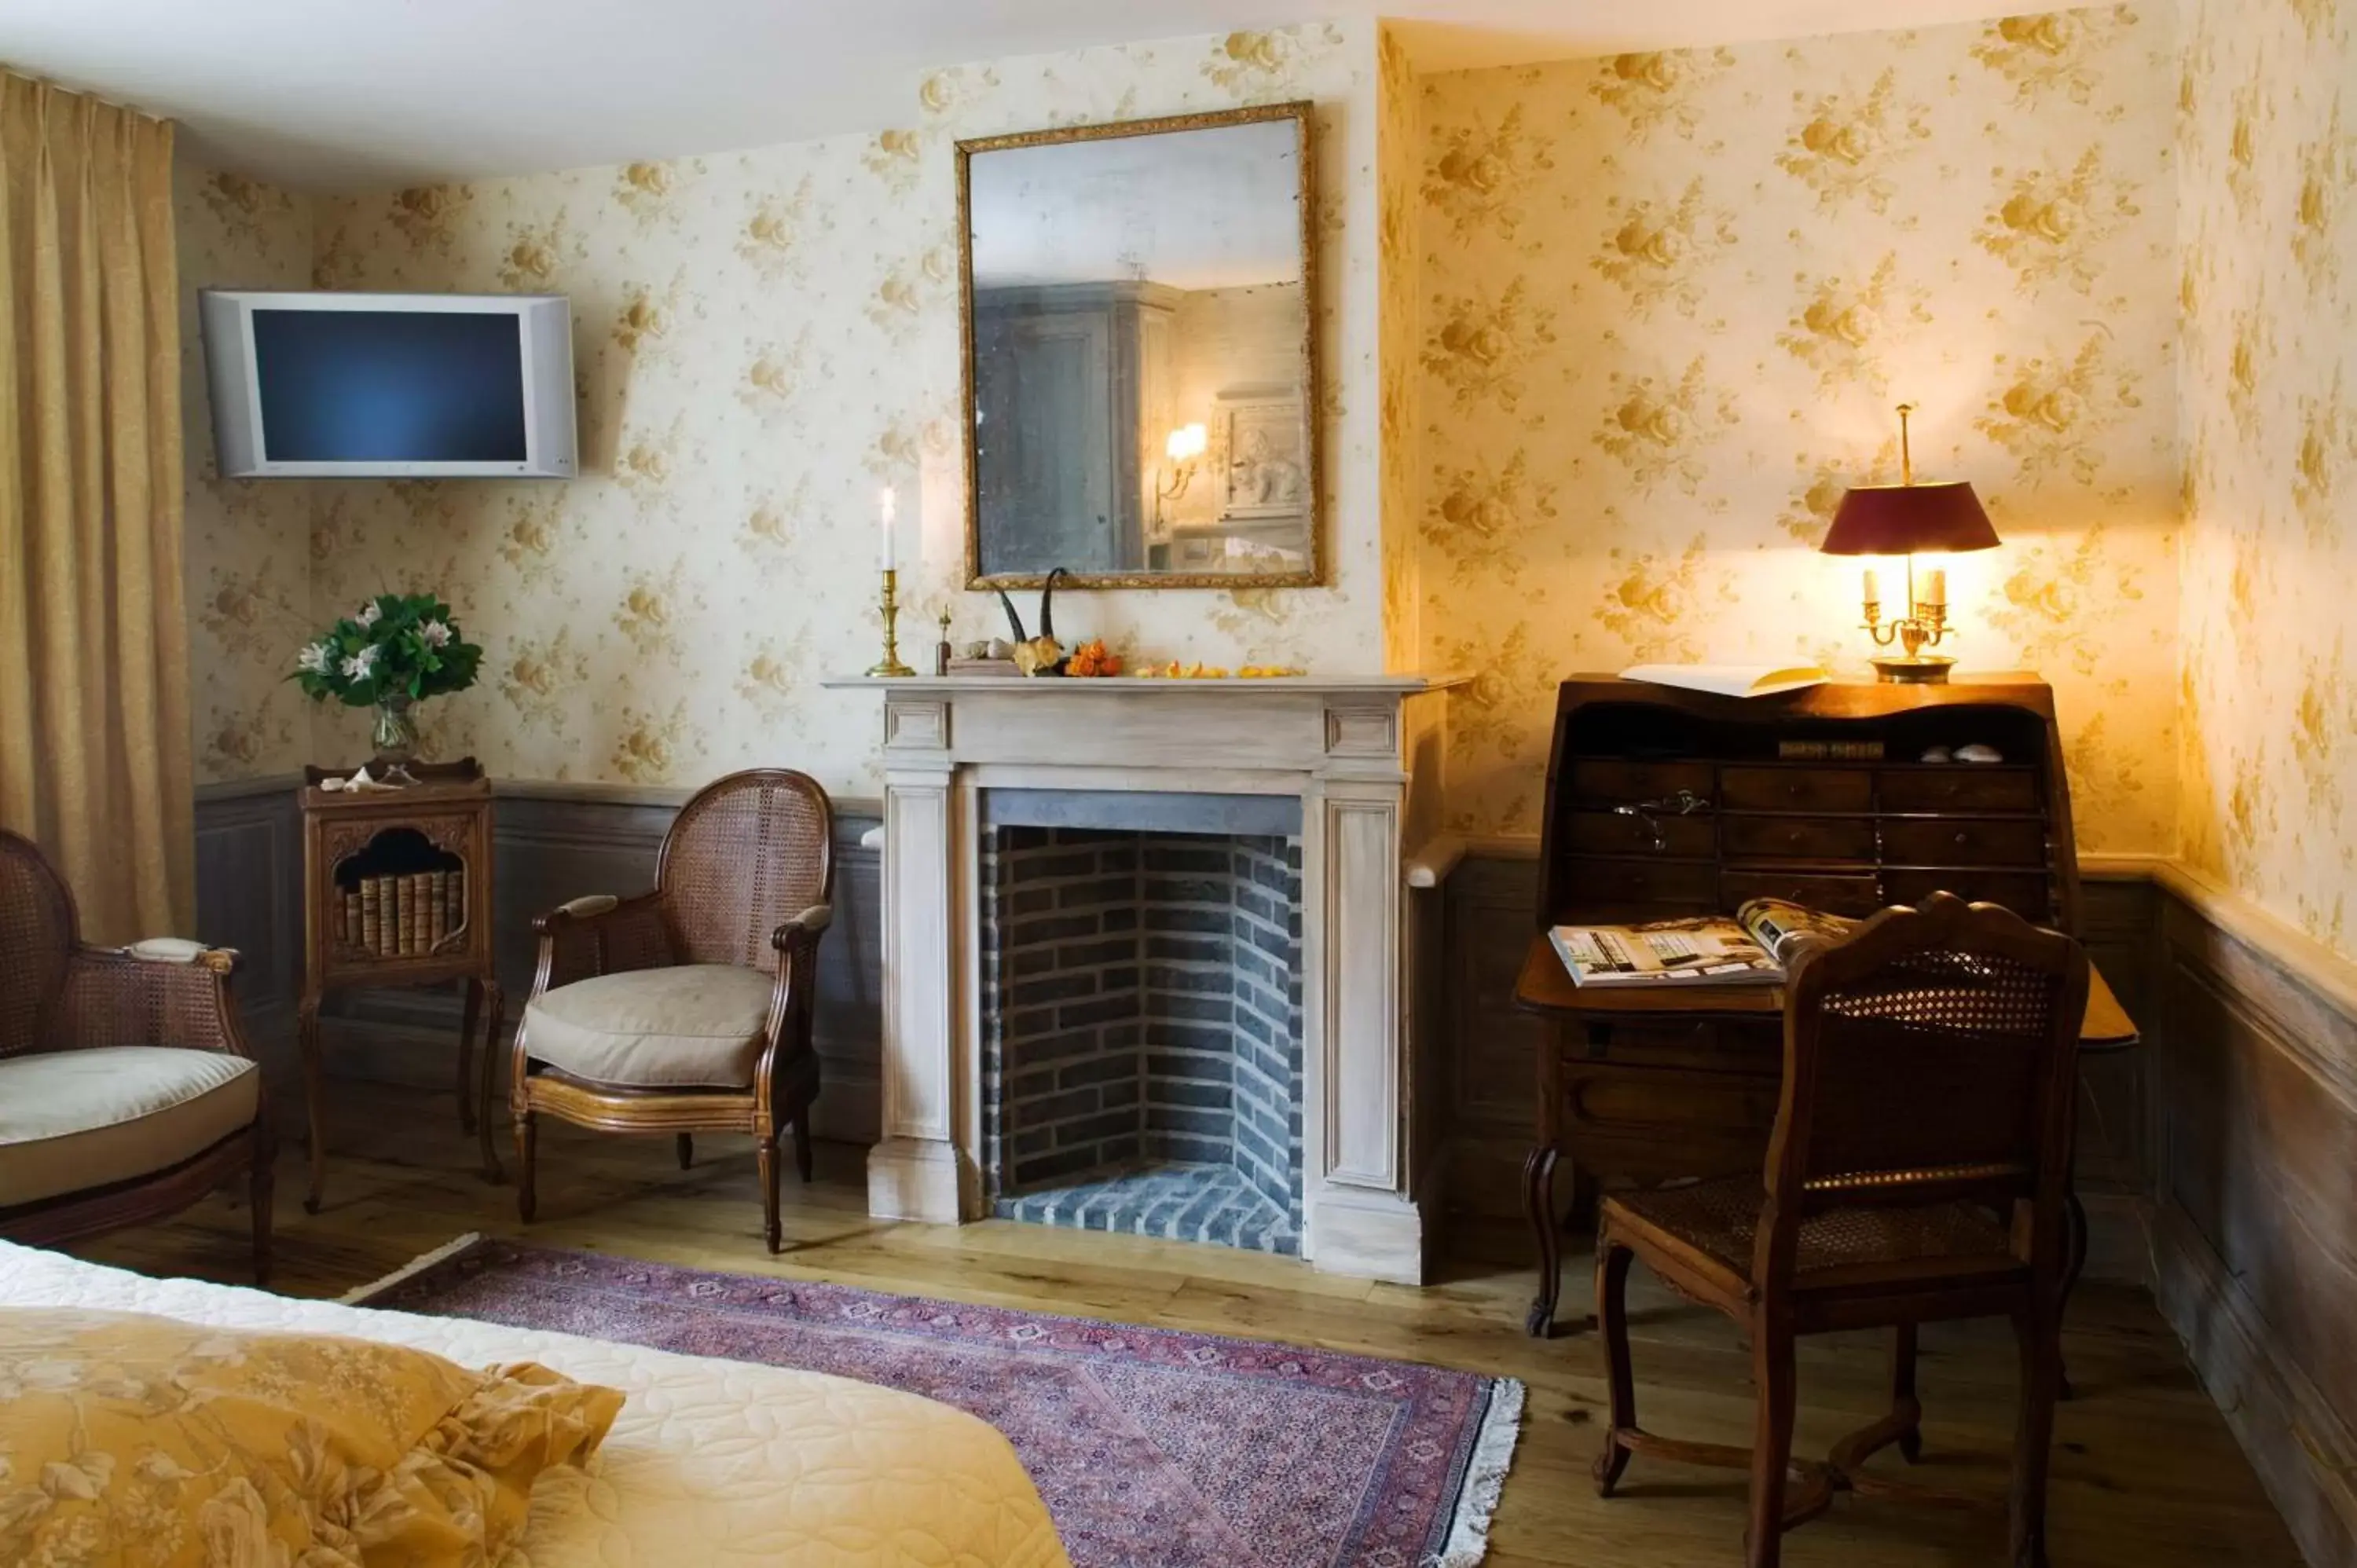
[0,830,276,1283]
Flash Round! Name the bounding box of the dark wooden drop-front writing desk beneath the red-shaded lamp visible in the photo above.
[1516,676,2135,1335]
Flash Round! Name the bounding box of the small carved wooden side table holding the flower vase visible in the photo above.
[299,757,502,1214]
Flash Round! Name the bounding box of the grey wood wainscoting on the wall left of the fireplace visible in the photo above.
[196,775,882,1144]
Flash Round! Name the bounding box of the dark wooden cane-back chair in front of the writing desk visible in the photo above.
[1596,894,2088,1568]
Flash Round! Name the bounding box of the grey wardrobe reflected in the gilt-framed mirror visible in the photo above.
[973,283,1176,573]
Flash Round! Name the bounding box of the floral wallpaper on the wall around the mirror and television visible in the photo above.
[271,24,1414,795]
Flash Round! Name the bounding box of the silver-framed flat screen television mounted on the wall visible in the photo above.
[198,288,577,478]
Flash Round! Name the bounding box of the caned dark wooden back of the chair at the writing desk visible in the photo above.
[1758,894,2088,1271]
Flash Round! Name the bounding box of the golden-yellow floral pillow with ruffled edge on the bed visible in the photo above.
[0,1309,622,1568]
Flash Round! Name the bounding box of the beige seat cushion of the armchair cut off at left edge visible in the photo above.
[0,1045,262,1207]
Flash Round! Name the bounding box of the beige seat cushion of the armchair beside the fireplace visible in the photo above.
[523,965,775,1090]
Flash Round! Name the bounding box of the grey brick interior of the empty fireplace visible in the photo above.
[981,820,1301,1252]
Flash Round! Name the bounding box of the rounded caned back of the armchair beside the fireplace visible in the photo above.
[655,768,834,972]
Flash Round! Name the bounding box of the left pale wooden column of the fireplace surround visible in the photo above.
[867,698,971,1224]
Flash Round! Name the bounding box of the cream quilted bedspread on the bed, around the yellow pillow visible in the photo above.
[0,1243,1070,1568]
